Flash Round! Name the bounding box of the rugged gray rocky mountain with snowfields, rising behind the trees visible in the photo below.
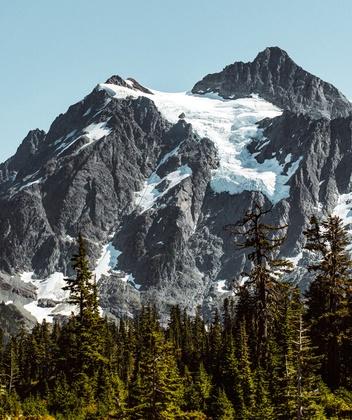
[0,47,352,320]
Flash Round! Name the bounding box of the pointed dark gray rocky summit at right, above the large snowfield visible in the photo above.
[192,47,352,118]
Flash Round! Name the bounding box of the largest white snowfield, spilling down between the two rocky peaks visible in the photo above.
[99,84,301,204]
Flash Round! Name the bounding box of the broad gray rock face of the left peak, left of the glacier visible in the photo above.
[0,90,197,276]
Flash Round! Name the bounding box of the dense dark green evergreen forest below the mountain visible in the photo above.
[0,208,352,420]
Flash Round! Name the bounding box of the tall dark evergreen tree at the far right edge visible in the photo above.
[304,216,352,389]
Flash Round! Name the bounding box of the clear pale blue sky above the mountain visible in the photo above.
[0,0,352,161]
